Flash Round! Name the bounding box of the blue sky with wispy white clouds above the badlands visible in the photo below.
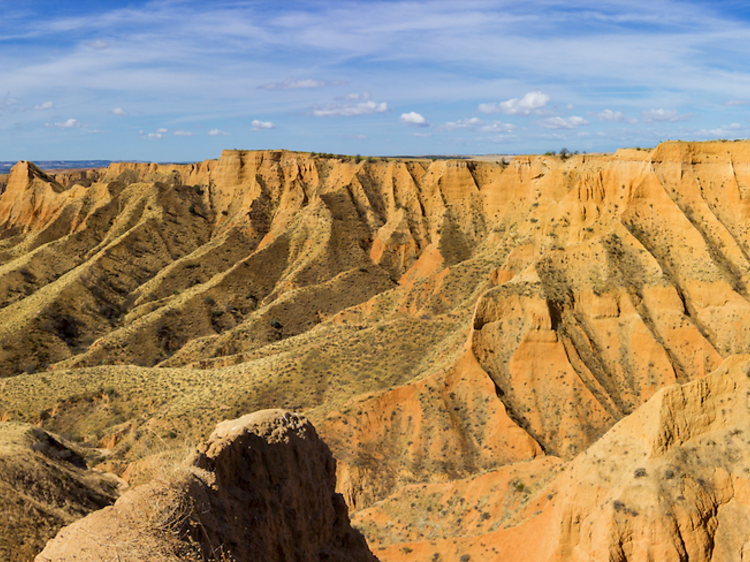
[0,0,750,162]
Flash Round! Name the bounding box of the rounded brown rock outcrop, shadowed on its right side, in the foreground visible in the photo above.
[36,410,377,562]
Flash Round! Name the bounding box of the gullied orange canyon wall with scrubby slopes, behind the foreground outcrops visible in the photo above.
[0,142,750,557]
